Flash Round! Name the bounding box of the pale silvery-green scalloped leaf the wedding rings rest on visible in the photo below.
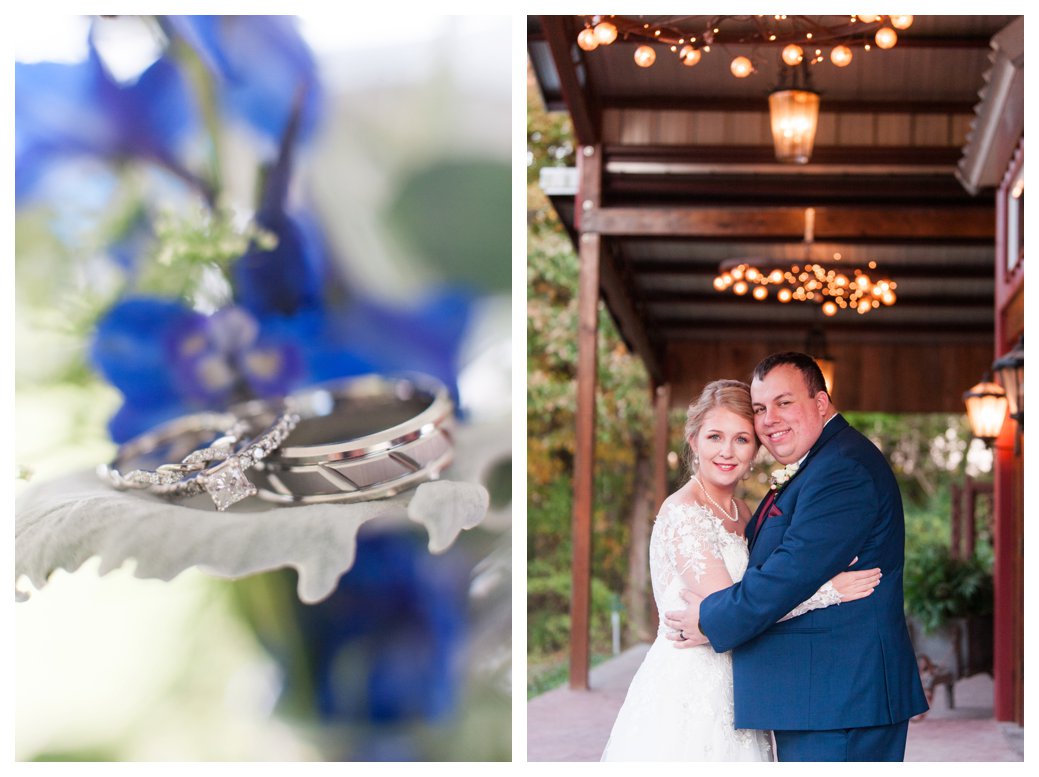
[15,425,508,604]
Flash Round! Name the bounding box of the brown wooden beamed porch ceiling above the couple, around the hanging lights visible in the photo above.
[528,16,1014,409]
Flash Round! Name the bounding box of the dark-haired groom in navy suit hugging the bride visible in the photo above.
[665,352,928,760]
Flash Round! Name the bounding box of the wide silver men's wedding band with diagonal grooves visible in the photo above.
[252,375,454,504]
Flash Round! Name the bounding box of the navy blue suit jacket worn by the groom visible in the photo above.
[700,416,927,730]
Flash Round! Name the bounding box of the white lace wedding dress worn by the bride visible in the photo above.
[603,502,840,761]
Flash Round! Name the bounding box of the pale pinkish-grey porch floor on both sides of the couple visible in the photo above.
[527,645,1023,761]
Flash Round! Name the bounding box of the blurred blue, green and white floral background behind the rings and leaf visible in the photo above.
[18,14,511,760]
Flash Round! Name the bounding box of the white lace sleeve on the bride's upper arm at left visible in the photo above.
[663,505,732,597]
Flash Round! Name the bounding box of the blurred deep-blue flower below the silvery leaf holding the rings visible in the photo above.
[297,532,471,726]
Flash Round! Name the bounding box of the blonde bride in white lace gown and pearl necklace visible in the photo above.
[603,380,880,760]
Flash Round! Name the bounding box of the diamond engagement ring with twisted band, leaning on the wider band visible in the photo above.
[98,402,299,511]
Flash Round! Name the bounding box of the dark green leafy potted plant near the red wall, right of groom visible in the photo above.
[904,544,992,632]
